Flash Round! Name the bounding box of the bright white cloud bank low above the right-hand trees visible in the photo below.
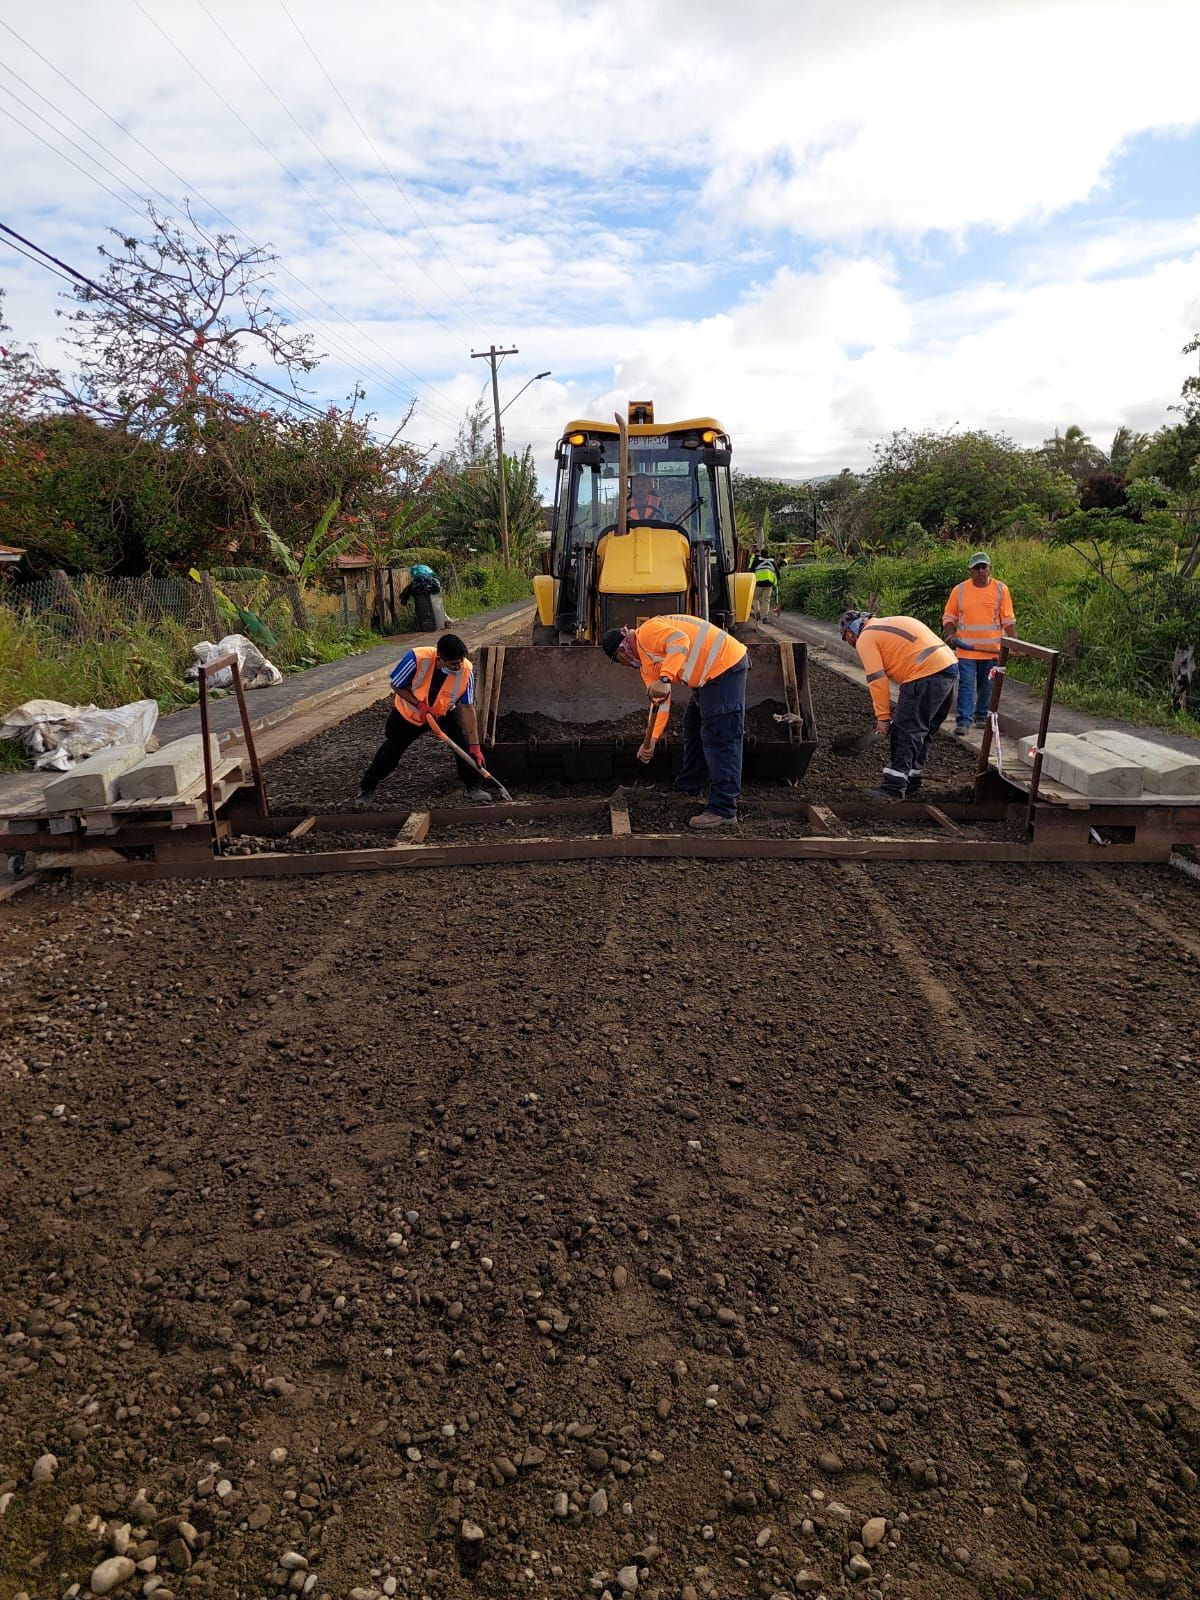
[579,251,1200,477]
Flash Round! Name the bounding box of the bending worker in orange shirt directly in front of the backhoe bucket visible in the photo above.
[602,616,749,829]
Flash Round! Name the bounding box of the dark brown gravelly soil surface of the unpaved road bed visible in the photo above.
[0,652,1200,1600]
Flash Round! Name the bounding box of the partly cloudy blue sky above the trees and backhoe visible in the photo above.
[0,0,1200,478]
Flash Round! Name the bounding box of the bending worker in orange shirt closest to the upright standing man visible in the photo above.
[838,611,958,800]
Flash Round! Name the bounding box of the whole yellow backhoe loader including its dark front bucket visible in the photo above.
[480,402,816,779]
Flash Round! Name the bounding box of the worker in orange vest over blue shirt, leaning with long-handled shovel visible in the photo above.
[354,634,491,810]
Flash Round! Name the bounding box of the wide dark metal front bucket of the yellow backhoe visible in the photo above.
[478,640,816,782]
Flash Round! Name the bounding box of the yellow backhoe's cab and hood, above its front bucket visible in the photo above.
[533,400,754,645]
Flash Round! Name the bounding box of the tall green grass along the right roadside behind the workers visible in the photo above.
[781,539,1200,734]
